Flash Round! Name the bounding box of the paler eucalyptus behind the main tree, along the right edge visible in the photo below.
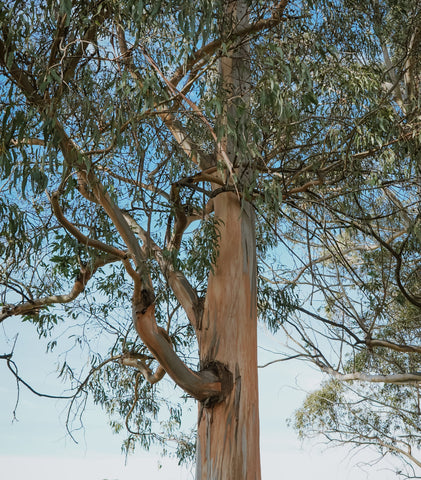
[279,1,421,478]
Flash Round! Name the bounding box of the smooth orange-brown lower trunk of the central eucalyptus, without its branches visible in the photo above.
[196,192,260,480]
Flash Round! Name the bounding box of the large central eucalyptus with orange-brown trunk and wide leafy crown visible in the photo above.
[0,0,421,479]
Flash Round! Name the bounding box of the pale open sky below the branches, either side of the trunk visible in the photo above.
[0,318,396,480]
